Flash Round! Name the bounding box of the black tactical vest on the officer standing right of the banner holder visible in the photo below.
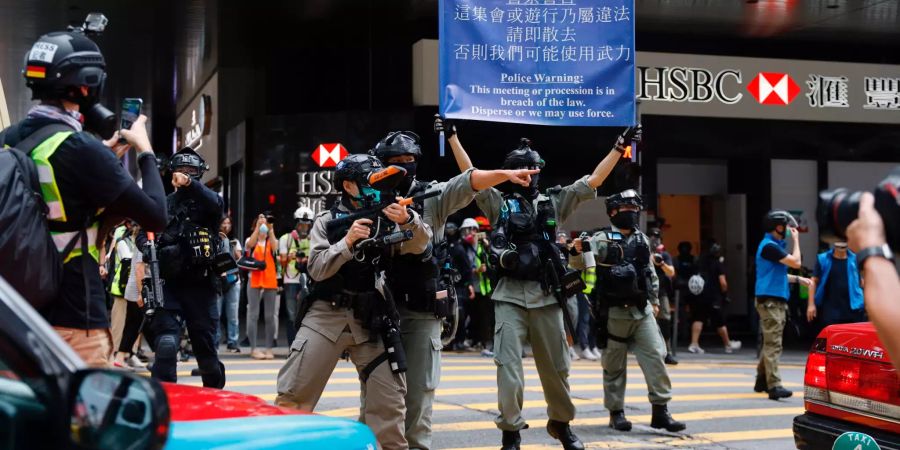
[596,228,653,309]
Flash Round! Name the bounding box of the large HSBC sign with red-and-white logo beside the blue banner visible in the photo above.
[635,52,900,123]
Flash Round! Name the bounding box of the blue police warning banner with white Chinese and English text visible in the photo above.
[439,0,635,126]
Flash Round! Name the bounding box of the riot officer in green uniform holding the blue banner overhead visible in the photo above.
[476,127,640,450]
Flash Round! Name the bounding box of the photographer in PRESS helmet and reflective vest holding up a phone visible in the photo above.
[0,18,166,367]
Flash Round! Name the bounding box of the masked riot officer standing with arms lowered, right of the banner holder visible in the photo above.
[570,189,685,432]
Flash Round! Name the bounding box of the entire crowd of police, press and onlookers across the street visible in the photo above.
[0,16,893,450]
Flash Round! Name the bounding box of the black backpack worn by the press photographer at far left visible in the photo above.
[0,124,87,309]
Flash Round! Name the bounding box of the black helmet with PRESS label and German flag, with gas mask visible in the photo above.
[22,29,116,139]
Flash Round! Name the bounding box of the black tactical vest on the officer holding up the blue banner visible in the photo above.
[491,193,560,281]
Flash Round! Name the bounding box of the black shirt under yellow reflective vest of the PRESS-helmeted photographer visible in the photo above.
[11,118,134,329]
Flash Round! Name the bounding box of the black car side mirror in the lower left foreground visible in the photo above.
[68,369,170,450]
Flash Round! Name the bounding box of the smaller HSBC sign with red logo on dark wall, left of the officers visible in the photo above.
[297,144,349,214]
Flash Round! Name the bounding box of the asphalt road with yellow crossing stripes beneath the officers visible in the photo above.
[178,349,805,450]
